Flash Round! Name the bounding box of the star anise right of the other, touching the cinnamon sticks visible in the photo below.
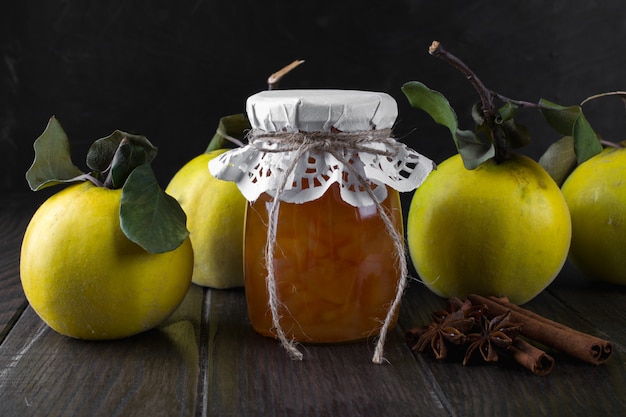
[463,310,522,365]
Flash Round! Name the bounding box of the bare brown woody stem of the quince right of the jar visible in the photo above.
[428,41,512,163]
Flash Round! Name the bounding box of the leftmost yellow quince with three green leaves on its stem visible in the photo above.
[20,117,193,339]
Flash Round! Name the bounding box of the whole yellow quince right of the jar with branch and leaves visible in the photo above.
[402,42,595,304]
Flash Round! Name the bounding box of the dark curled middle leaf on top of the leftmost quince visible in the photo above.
[87,130,158,188]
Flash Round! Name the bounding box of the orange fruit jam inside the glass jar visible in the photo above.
[244,183,403,343]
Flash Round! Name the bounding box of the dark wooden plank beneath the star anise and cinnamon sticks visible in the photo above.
[400,278,626,416]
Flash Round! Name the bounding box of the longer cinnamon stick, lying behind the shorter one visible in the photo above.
[467,294,613,365]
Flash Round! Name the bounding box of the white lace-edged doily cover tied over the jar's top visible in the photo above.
[209,90,434,207]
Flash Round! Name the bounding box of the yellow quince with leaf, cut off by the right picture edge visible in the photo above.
[539,91,626,285]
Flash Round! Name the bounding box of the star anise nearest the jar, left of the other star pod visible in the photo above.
[407,309,475,359]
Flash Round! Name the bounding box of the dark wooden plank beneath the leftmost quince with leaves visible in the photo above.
[0,286,203,417]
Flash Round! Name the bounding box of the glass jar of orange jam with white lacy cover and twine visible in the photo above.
[209,90,434,361]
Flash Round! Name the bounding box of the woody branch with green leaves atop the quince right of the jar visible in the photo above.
[402,41,608,183]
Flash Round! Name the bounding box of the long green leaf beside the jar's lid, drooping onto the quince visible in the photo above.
[402,81,495,169]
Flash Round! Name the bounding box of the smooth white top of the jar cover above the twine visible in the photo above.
[246,89,398,132]
